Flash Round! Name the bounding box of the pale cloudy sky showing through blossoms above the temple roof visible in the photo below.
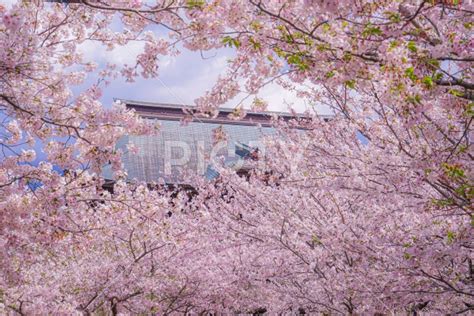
[0,0,328,114]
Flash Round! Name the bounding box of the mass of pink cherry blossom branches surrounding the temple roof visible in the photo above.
[0,0,474,314]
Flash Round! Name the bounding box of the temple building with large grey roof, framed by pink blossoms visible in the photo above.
[105,100,328,184]
